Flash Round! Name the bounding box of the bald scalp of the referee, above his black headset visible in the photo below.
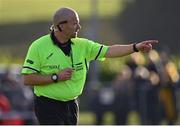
[53,7,78,26]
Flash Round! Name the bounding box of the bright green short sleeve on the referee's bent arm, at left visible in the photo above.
[21,43,40,74]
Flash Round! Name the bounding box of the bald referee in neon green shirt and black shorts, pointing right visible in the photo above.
[22,7,158,125]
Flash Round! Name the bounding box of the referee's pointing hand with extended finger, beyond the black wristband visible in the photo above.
[136,40,158,53]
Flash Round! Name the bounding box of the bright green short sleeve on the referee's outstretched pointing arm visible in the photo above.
[86,40,109,61]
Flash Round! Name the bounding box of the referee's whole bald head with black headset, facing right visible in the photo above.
[51,7,81,39]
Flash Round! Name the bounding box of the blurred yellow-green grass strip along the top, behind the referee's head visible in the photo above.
[0,0,125,24]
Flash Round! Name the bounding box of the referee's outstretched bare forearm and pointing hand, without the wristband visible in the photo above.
[105,40,158,58]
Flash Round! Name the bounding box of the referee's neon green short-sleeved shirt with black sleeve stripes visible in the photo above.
[22,35,108,101]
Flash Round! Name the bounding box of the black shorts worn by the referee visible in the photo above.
[34,96,79,125]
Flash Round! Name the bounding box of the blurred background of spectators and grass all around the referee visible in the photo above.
[0,0,180,125]
